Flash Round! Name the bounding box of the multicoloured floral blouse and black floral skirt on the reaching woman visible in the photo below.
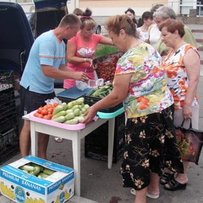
[118,42,183,190]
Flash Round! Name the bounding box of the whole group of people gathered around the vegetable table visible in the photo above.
[20,5,200,203]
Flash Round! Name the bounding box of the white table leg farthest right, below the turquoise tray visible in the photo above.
[108,118,115,169]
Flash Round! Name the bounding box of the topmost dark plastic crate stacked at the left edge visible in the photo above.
[0,71,14,92]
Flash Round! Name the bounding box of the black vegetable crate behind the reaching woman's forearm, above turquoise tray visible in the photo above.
[84,95,123,113]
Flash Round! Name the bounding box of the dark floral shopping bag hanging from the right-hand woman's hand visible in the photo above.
[175,119,203,164]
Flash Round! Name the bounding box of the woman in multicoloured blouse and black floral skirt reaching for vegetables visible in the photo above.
[84,15,183,203]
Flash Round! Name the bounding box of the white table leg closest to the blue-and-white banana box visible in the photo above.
[72,134,81,196]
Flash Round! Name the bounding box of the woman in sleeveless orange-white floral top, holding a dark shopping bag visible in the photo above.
[160,19,200,191]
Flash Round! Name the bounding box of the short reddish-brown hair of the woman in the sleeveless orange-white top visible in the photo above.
[159,19,185,37]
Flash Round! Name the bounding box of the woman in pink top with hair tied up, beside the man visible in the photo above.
[64,9,112,89]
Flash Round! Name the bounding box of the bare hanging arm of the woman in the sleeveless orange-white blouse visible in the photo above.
[183,49,200,118]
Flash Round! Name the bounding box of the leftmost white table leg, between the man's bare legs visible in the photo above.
[30,121,38,156]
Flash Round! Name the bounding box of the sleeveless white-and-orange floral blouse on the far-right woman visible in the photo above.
[163,44,197,109]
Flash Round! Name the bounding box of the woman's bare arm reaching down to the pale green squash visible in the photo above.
[84,74,132,123]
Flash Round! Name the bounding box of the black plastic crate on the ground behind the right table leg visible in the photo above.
[85,114,125,163]
